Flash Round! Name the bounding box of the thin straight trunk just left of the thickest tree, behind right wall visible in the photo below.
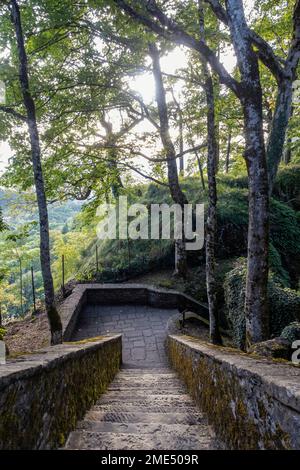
[198,0,222,344]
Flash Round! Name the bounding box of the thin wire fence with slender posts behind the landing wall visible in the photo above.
[0,239,173,324]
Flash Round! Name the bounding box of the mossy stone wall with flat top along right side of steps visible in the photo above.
[168,336,300,450]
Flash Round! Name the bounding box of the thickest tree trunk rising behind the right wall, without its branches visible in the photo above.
[226,0,269,347]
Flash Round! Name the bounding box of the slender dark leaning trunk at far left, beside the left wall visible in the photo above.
[9,0,62,344]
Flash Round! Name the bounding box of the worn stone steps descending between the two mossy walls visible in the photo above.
[65,368,216,450]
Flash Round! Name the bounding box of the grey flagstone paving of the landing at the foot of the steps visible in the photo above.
[73,305,178,368]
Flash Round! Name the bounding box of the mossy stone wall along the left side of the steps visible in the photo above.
[0,335,122,450]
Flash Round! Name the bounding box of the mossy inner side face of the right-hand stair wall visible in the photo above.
[168,337,300,450]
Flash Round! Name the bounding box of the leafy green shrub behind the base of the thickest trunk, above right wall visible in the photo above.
[224,259,300,349]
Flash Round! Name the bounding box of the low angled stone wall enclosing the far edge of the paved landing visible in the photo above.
[60,284,208,341]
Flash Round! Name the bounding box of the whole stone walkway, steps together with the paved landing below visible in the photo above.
[65,305,215,450]
